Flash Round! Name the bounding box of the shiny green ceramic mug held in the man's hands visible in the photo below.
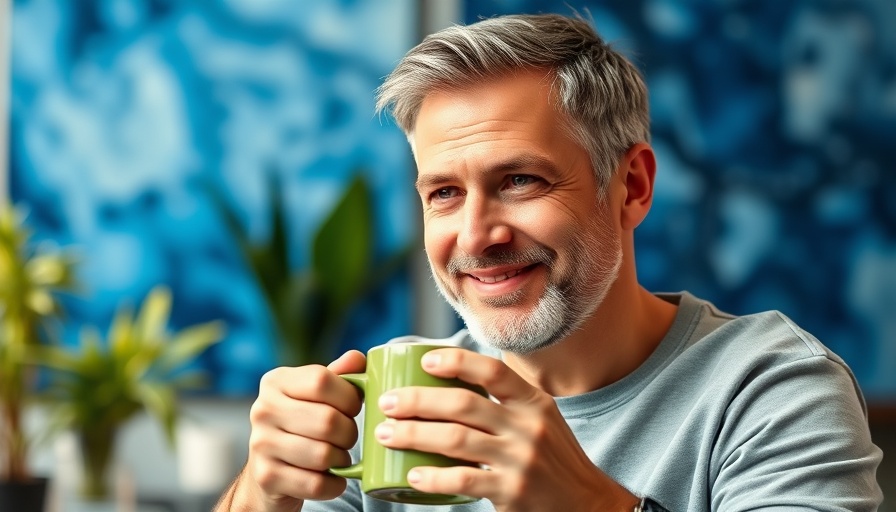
[330,336,488,505]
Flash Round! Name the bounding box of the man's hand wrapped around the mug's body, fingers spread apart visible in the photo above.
[376,349,638,512]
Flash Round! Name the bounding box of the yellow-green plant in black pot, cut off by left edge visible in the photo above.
[0,205,74,511]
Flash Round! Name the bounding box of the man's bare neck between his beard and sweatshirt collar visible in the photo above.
[503,265,677,396]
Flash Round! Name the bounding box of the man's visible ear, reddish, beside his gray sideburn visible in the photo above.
[616,142,656,230]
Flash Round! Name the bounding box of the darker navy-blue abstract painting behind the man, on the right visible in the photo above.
[465,0,896,402]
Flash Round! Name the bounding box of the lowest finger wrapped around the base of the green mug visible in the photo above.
[408,466,503,501]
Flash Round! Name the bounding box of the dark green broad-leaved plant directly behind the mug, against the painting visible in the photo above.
[209,172,414,366]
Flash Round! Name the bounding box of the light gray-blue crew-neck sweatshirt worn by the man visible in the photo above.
[303,293,883,512]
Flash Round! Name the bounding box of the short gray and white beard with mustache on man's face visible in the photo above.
[430,206,622,355]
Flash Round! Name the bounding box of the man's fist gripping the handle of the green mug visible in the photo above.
[216,350,367,512]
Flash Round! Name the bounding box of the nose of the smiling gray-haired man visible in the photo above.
[457,195,512,256]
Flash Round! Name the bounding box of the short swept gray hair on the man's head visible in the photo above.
[376,14,650,190]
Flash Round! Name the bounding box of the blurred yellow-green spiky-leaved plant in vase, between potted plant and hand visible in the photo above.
[33,286,223,499]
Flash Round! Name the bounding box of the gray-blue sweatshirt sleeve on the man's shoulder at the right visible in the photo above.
[710,350,883,511]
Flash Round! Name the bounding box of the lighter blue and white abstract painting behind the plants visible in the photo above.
[9,0,419,396]
